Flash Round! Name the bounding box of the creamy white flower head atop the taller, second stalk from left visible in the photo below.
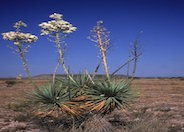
[39,13,77,35]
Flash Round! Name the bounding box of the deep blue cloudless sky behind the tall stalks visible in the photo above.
[0,0,184,77]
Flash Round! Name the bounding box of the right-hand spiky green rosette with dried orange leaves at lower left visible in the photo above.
[86,81,133,114]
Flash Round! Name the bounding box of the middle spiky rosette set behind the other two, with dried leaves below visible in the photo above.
[51,72,94,114]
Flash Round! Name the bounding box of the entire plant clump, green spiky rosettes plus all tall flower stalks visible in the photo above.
[2,13,142,131]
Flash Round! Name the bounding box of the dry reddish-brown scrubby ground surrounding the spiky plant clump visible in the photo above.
[0,79,184,132]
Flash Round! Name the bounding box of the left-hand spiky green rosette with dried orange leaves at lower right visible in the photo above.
[29,84,80,116]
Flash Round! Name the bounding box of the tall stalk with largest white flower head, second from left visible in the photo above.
[39,13,77,83]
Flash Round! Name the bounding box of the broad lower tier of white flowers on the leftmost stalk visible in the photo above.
[2,31,38,45]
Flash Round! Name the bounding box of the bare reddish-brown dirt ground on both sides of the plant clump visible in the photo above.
[0,79,184,132]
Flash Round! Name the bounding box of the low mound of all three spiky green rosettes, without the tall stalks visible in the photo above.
[30,75,134,118]
